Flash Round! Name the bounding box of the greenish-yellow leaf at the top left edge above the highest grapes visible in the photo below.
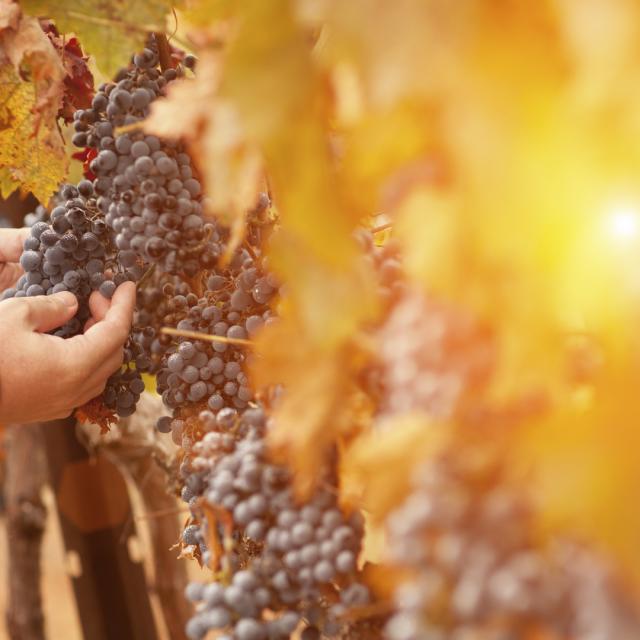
[21,0,174,76]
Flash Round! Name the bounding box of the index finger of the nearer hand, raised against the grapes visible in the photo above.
[67,282,136,368]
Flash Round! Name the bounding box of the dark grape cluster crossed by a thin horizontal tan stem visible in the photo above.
[149,205,278,436]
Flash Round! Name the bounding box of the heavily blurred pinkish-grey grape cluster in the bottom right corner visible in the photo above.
[386,451,640,640]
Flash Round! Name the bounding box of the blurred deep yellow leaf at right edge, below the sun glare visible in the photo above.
[512,356,640,585]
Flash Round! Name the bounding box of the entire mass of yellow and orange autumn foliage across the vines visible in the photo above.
[0,0,640,640]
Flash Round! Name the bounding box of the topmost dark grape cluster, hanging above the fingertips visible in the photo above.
[73,37,210,277]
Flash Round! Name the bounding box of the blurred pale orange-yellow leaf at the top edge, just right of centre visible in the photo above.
[315,0,481,108]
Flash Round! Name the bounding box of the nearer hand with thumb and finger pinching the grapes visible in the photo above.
[0,282,136,424]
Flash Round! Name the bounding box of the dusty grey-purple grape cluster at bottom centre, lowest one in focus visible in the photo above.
[183,407,370,640]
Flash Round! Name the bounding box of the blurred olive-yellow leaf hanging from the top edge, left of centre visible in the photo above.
[220,0,357,268]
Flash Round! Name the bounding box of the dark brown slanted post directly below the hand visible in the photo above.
[43,419,157,640]
